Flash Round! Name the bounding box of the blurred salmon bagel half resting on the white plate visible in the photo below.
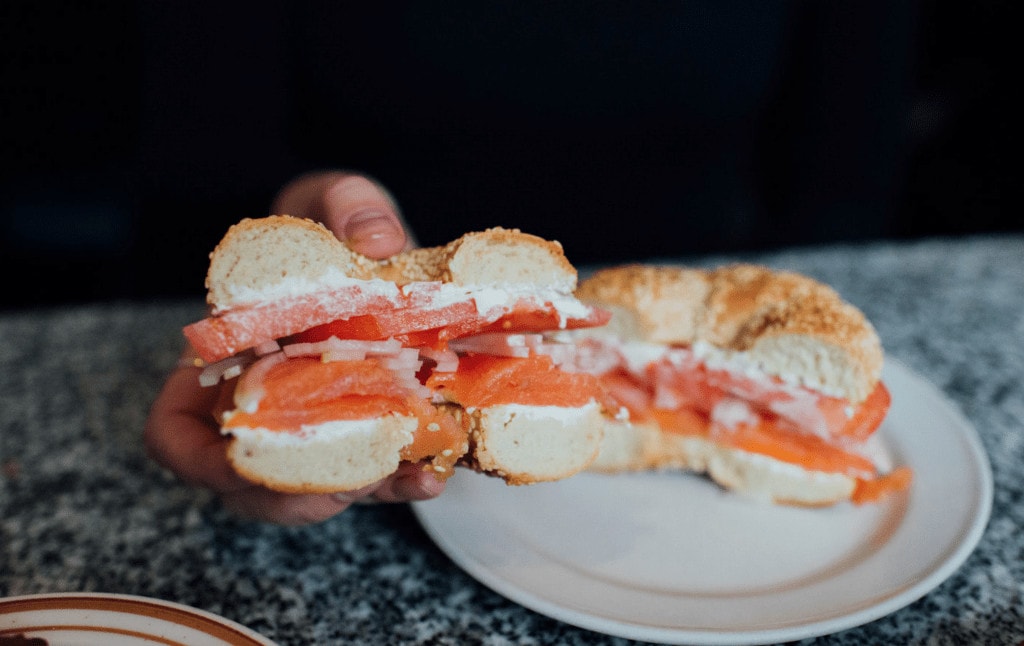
[572,264,911,506]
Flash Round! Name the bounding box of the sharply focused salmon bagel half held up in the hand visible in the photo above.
[183,215,608,492]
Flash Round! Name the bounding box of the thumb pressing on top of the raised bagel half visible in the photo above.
[273,172,414,258]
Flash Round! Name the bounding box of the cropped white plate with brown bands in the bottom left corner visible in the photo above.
[0,593,273,646]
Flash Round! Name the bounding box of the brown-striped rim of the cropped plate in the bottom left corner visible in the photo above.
[0,592,278,646]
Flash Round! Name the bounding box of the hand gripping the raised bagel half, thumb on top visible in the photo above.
[144,171,444,524]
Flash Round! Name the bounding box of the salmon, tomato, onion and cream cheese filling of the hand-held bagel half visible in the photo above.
[185,279,608,477]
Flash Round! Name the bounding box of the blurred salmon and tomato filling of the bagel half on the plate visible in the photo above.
[565,338,909,502]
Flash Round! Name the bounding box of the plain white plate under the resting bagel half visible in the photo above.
[414,361,992,644]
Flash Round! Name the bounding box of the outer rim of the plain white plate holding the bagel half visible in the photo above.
[411,357,994,646]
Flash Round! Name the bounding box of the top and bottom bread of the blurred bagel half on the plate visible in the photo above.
[577,264,897,507]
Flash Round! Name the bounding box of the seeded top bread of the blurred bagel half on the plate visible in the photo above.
[577,264,883,404]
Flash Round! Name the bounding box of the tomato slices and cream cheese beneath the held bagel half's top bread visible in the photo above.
[184,278,608,362]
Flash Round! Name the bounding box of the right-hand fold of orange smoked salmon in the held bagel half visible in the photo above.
[427,353,603,407]
